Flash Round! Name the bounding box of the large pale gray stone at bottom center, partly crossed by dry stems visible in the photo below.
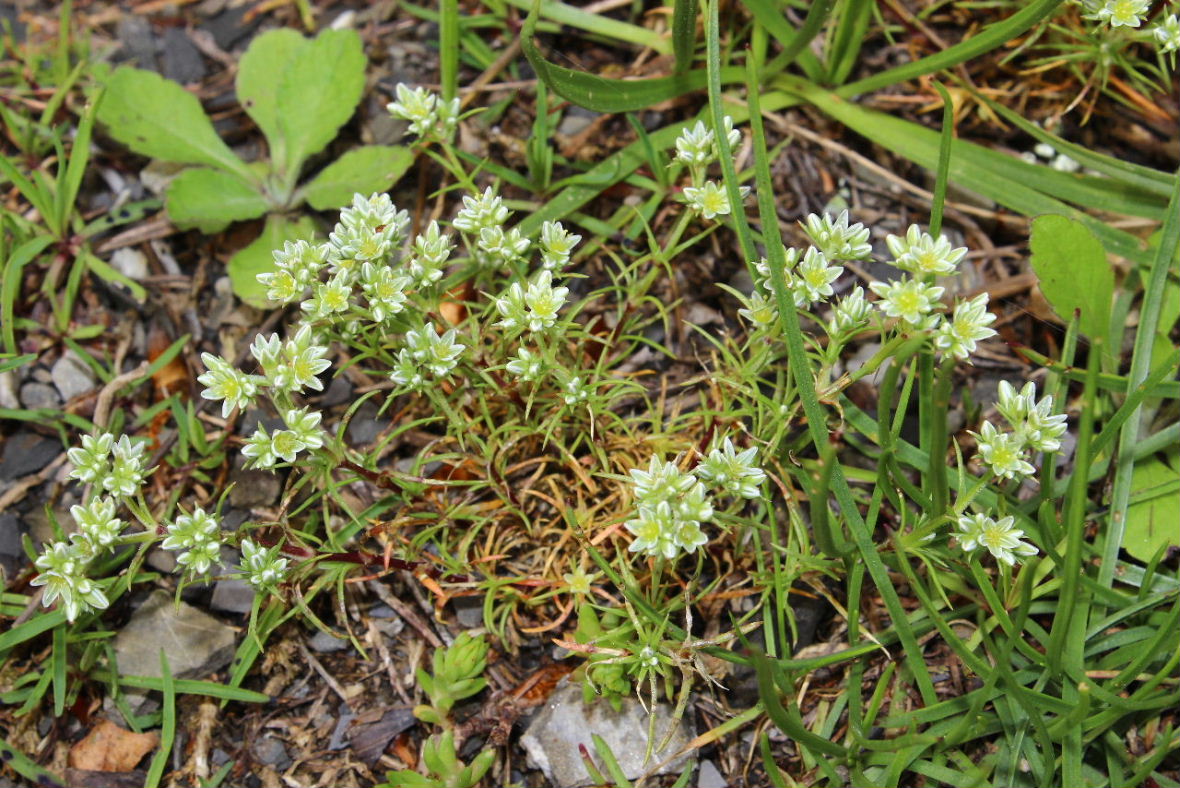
[520,679,691,788]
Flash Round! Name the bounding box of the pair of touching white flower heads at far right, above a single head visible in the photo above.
[971,381,1066,479]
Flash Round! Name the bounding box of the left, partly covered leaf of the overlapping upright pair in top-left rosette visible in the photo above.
[234,27,308,162]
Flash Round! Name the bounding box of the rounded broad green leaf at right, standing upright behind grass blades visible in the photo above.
[1029,215,1114,339]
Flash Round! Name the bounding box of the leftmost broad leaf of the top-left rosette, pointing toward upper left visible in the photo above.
[98,66,254,180]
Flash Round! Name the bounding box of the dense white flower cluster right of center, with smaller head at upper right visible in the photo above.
[624,438,766,559]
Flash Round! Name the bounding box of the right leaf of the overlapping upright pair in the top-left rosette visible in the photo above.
[275,31,366,180]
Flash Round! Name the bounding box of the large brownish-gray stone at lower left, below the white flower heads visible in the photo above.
[114,591,234,678]
